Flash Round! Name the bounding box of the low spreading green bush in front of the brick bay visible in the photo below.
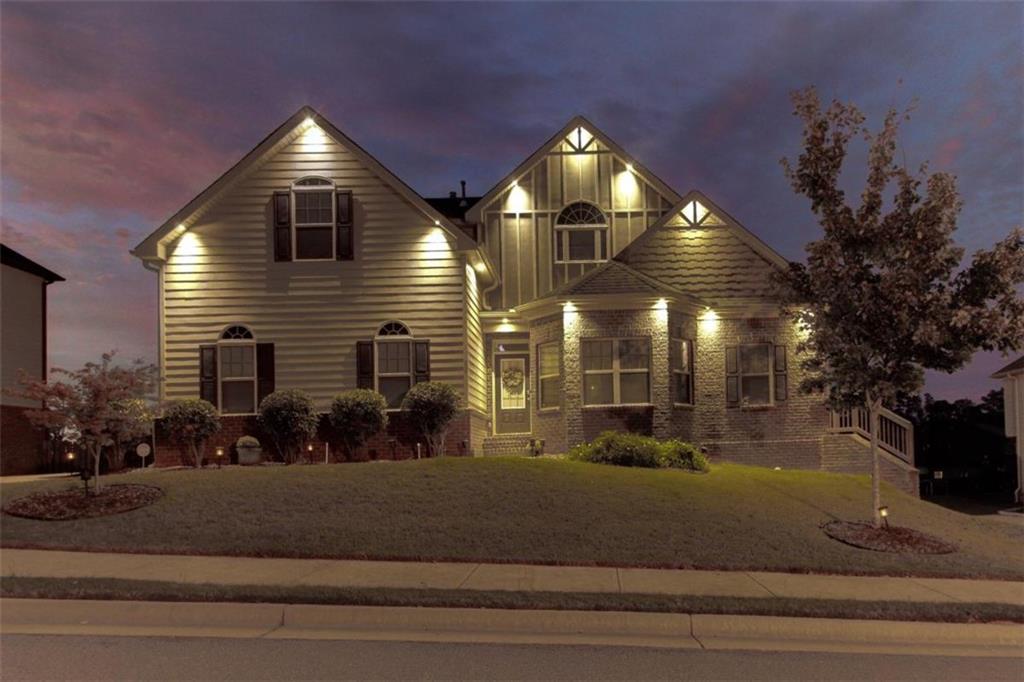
[568,431,708,471]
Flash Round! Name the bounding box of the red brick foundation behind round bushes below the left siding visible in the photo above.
[155,411,482,467]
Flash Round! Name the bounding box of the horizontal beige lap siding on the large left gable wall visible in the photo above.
[164,128,466,408]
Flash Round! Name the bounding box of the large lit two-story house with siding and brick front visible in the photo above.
[133,108,916,491]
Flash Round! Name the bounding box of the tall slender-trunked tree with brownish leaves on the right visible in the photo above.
[779,88,1024,526]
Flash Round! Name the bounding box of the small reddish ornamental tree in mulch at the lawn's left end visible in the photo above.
[11,350,158,493]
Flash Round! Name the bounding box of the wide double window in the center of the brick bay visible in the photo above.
[581,339,650,404]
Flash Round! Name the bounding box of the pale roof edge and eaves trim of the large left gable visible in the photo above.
[131,105,477,260]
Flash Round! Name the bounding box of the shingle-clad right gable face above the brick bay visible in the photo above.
[614,190,788,300]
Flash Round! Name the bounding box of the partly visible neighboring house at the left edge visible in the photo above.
[0,245,65,475]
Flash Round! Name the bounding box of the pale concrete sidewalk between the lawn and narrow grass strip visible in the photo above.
[0,549,1024,606]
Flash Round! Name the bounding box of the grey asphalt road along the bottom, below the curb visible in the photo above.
[0,635,1024,682]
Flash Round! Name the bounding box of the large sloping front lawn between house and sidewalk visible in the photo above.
[0,458,1024,579]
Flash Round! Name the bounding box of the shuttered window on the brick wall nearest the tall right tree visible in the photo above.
[725,343,786,407]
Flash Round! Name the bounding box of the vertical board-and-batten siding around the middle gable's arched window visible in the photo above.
[480,140,671,309]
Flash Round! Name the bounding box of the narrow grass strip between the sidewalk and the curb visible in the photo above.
[0,578,1024,623]
